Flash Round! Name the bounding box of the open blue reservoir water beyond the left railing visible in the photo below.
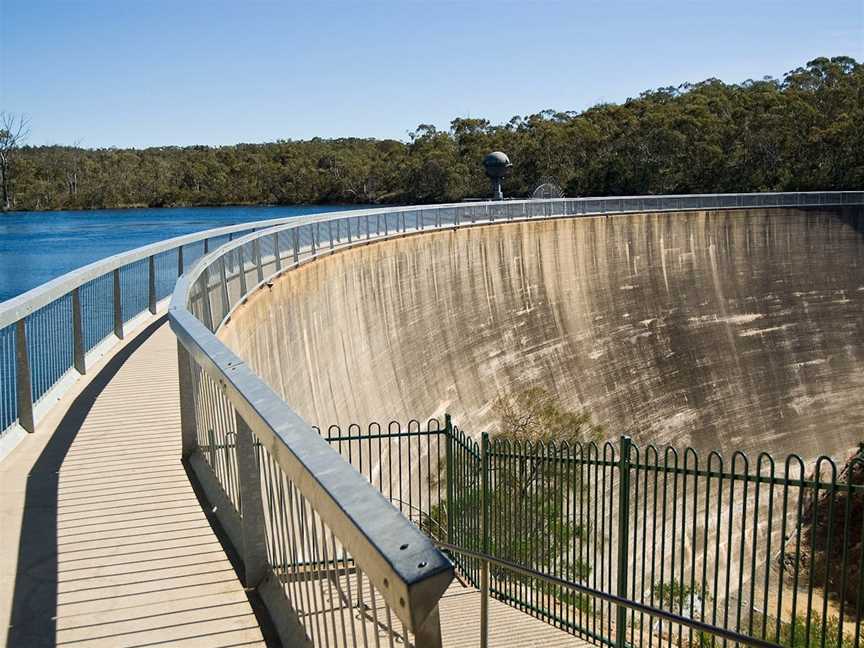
[0,205,356,302]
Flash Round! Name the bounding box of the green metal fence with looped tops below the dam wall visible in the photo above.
[316,418,864,648]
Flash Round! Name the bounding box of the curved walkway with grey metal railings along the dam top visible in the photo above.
[0,192,864,648]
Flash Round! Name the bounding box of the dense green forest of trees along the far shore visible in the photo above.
[6,57,864,209]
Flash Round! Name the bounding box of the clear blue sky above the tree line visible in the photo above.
[0,0,864,147]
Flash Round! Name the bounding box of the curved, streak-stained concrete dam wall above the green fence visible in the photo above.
[220,209,864,458]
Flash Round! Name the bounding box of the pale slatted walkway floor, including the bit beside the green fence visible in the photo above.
[0,321,584,648]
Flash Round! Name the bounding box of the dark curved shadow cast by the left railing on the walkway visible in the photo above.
[7,316,167,648]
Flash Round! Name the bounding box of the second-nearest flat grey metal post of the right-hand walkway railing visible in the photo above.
[235,413,267,588]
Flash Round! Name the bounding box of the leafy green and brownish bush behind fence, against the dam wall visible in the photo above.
[423,387,602,611]
